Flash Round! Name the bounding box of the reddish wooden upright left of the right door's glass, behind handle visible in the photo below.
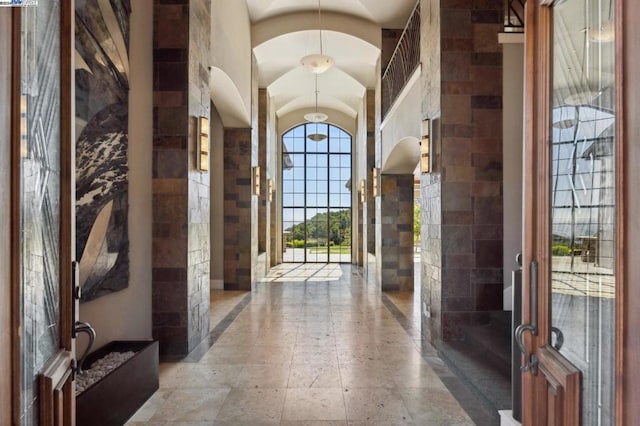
[522,0,551,425]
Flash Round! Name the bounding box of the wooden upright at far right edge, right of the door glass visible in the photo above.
[615,0,640,425]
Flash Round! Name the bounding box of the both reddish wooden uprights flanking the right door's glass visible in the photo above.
[522,0,628,425]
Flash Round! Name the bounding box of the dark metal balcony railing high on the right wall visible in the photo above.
[382,1,420,118]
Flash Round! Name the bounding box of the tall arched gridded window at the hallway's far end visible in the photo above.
[282,123,351,263]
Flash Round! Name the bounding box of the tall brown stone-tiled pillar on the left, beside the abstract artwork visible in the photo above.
[152,0,211,355]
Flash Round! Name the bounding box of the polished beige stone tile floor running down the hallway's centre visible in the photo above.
[127,265,473,426]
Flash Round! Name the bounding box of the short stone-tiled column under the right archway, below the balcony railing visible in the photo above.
[378,174,413,291]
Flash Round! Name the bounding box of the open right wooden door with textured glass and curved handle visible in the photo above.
[516,0,622,425]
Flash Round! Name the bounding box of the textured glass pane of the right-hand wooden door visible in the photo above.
[550,0,616,425]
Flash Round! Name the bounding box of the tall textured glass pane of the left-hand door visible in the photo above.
[20,0,60,424]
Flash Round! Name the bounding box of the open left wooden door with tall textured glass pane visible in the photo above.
[11,0,77,425]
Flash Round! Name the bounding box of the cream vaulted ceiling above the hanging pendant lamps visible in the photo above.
[247,0,416,118]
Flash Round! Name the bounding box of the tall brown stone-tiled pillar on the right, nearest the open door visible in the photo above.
[421,0,503,340]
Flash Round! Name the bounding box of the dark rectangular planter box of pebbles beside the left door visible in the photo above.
[76,341,159,426]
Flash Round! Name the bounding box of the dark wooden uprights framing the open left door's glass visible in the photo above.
[10,0,77,424]
